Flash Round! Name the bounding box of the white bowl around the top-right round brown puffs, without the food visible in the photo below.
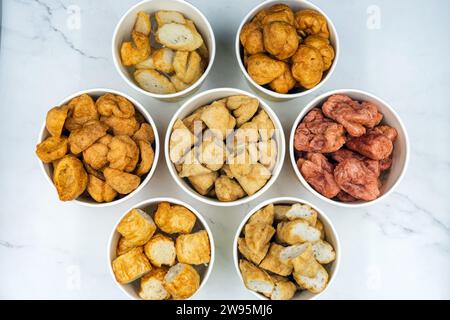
[235,0,340,100]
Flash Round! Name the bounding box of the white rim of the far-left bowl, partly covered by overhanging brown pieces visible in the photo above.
[37,88,161,208]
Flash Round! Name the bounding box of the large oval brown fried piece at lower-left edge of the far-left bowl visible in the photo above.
[53,155,88,201]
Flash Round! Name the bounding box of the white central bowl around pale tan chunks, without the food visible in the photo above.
[164,88,286,207]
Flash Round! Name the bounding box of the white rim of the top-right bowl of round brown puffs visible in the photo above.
[235,0,341,100]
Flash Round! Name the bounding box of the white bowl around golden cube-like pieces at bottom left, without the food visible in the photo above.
[107,198,215,300]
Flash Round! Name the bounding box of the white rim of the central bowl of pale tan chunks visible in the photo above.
[164,88,286,207]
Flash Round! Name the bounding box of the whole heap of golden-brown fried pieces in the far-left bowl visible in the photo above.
[36,93,155,202]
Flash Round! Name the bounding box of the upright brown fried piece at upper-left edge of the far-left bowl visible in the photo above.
[65,94,99,131]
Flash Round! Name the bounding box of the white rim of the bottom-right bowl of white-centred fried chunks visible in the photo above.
[233,197,342,300]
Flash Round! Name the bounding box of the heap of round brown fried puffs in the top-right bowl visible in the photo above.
[240,4,335,94]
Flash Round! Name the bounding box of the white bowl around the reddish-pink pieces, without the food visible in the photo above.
[289,89,409,208]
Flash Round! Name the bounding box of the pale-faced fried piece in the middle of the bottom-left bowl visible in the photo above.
[144,234,176,267]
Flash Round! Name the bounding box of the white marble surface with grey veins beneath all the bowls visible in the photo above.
[0,0,450,299]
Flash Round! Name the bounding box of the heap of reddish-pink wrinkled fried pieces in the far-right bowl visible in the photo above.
[294,95,398,202]
